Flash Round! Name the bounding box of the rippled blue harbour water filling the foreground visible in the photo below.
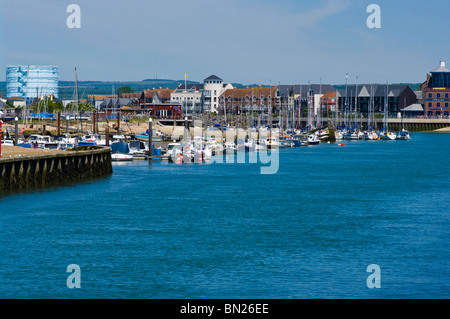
[0,133,450,299]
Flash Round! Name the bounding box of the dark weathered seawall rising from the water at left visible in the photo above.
[0,147,112,193]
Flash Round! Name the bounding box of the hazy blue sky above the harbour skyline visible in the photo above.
[0,0,450,84]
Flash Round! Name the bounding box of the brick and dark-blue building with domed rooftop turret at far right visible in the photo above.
[422,61,450,117]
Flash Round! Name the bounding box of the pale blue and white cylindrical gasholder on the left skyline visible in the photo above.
[6,65,59,99]
